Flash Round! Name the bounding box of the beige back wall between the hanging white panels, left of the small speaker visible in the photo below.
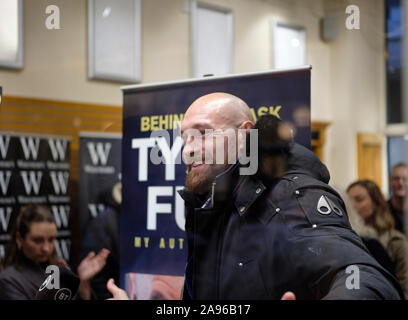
[0,0,330,108]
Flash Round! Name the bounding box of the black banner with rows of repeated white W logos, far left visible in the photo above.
[0,133,71,262]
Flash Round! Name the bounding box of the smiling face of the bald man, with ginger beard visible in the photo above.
[181,105,237,194]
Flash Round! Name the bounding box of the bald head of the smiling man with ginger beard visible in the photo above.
[181,92,254,194]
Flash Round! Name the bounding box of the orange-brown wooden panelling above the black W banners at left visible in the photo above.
[0,96,122,180]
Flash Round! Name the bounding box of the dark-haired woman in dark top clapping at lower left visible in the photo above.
[0,205,109,300]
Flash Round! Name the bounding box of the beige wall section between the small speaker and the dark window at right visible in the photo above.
[325,0,387,192]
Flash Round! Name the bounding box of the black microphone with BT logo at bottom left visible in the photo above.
[35,266,80,301]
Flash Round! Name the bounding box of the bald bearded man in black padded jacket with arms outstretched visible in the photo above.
[108,92,402,300]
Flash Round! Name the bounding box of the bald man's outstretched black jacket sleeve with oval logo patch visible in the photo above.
[286,185,403,300]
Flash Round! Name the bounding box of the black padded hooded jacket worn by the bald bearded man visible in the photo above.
[180,144,402,299]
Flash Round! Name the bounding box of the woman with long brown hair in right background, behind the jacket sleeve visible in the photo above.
[347,179,408,299]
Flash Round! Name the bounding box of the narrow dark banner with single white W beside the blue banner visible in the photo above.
[79,132,122,238]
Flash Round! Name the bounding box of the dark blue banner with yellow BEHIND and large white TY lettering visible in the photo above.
[120,67,310,299]
